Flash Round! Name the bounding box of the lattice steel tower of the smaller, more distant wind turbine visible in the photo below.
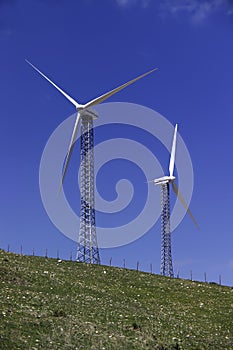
[160,182,174,277]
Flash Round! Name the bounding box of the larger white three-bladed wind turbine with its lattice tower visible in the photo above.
[26,60,157,264]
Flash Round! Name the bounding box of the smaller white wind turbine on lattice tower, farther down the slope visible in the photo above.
[153,124,199,277]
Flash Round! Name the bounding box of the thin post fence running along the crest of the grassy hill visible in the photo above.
[2,244,222,286]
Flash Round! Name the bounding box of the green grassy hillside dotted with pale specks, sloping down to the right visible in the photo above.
[0,250,233,350]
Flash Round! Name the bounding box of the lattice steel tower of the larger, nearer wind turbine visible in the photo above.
[77,113,100,264]
